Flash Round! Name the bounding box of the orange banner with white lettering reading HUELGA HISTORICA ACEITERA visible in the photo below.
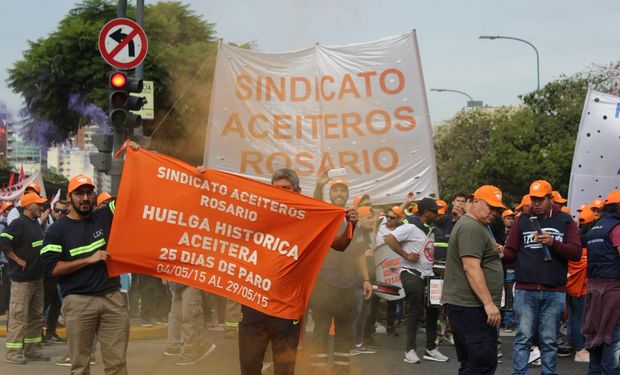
[108,149,345,319]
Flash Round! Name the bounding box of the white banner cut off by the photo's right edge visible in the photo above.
[568,90,620,212]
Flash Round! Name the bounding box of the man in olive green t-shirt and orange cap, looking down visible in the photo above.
[441,185,506,374]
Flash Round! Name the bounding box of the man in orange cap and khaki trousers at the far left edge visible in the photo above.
[0,193,50,365]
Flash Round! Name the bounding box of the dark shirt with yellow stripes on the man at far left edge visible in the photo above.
[0,215,43,282]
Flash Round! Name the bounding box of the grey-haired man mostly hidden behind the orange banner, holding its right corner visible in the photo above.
[239,168,357,375]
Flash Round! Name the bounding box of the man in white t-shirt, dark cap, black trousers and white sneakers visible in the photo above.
[385,198,448,363]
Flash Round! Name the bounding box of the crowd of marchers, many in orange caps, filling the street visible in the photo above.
[0,160,620,375]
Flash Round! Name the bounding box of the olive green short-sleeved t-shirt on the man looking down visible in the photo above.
[441,215,504,307]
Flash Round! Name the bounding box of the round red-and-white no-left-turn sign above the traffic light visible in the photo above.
[99,18,148,69]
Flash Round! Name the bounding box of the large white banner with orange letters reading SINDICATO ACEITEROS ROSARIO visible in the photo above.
[204,32,437,204]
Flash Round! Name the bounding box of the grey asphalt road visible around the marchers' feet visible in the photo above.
[0,327,587,375]
